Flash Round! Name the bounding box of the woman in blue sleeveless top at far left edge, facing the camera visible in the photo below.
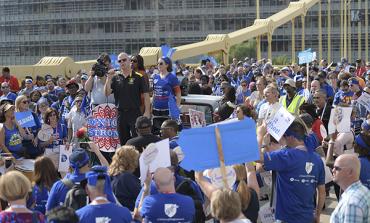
[0,103,33,159]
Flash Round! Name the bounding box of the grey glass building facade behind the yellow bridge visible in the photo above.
[0,0,369,65]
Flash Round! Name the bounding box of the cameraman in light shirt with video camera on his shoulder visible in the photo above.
[84,54,114,108]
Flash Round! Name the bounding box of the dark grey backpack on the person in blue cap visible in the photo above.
[62,179,88,210]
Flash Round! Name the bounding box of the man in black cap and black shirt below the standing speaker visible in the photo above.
[126,116,161,153]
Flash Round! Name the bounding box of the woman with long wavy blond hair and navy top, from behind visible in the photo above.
[108,146,141,211]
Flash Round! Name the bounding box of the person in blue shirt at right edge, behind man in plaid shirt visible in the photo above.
[354,133,370,189]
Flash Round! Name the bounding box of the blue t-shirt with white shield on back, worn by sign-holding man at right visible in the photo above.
[264,148,325,223]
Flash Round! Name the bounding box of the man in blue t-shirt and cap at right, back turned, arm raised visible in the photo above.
[261,119,325,223]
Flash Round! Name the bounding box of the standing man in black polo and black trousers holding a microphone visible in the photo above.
[104,53,150,145]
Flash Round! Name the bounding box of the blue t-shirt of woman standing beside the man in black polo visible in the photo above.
[153,73,180,109]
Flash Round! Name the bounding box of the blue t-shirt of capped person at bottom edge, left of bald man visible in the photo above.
[76,203,132,223]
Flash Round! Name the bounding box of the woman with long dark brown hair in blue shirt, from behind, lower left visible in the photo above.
[28,156,58,214]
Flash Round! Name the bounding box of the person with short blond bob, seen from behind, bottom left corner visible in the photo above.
[0,171,46,223]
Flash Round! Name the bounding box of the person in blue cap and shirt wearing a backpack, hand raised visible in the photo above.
[46,143,116,211]
